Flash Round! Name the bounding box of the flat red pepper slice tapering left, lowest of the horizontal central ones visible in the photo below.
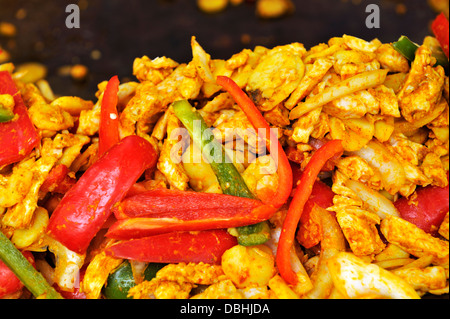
[105,229,237,264]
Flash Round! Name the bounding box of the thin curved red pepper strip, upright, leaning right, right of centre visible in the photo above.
[276,140,344,285]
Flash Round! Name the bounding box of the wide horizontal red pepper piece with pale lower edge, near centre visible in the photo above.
[106,189,276,239]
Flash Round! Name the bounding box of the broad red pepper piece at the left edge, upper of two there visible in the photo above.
[0,71,39,168]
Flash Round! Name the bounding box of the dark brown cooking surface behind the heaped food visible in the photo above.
[0,0,435,99]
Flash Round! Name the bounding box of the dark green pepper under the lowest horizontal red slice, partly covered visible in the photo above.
[103,260,165,299]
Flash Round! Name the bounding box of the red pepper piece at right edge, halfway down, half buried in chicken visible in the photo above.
[394,173,449,236]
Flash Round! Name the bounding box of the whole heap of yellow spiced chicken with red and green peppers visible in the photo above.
[0,17,449,299]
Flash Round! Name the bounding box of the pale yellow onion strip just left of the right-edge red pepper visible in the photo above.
[345,179,399,219]
